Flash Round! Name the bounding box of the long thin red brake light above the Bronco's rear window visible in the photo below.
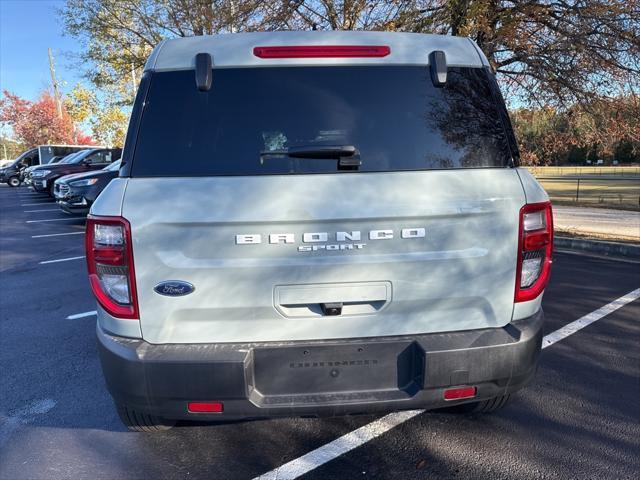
[253,45,391,58]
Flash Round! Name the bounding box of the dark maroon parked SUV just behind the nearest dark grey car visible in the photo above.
[31,148,122,197]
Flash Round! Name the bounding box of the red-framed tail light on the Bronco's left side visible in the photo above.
[85,215,138,319]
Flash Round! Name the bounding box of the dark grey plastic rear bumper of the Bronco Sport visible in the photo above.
[97,311,544,420]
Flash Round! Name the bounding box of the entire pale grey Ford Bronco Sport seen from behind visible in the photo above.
[86,32,553,430]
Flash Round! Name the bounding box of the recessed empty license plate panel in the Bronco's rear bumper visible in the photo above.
[246,341,425,406]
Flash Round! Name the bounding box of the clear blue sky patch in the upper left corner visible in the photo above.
[0,0,82,100]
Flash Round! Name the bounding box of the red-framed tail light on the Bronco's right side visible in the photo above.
[515,202,553,302]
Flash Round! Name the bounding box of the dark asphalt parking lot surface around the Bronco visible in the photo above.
[0,185,640,479]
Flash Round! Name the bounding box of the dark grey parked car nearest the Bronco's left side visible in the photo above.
[53,160,120,215]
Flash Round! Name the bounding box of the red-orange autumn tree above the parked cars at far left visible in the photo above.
[0,91,91,148]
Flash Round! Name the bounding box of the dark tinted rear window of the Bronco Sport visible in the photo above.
[131,66,510,176]
